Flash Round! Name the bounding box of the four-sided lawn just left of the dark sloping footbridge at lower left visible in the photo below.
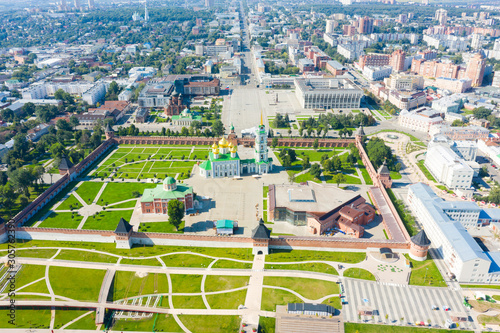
[49,266,106,302]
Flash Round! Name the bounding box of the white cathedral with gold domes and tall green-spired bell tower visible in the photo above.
[200,119,273,178]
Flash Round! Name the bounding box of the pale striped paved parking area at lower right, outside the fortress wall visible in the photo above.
[342,279,476,329]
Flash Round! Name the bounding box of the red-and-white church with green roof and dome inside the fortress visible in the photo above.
[141,177,193,214]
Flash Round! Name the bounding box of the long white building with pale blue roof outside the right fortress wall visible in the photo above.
[407,183,500,284]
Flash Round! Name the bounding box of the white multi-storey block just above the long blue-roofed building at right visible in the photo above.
[424,145,474,189]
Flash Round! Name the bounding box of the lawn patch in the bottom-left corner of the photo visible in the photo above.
[0,307,51,329]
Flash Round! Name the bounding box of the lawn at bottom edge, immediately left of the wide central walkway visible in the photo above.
[179,315,241,333]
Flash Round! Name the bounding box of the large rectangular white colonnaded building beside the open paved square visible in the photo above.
[294,78,363,109]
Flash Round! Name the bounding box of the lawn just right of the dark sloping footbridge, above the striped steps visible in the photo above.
[108,271,168,304]
